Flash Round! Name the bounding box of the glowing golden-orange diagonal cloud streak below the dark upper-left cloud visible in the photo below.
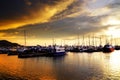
[0,0,74,30]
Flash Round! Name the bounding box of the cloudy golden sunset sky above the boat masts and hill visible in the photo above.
[0,0,120,45]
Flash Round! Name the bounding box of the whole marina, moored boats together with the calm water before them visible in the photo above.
[0,41,120,80]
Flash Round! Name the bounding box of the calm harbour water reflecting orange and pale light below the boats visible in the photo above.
[0,51,120,80]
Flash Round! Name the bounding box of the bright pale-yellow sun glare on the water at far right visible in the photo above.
[101,51,120,80]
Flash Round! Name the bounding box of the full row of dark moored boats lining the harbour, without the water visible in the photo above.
[0,44,120,58]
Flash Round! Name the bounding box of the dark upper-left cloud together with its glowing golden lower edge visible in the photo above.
[0,0,79,29]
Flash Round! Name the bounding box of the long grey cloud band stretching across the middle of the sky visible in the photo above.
[0,15,109,38]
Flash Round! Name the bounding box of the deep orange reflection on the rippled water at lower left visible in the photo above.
[0,54,56,80]
